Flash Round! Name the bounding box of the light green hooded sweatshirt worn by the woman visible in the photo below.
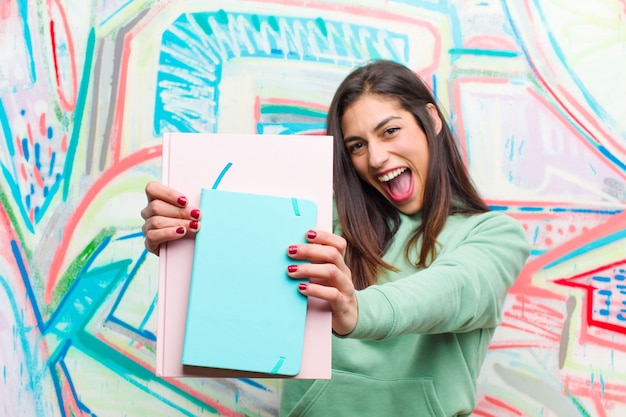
[280,212,529,417]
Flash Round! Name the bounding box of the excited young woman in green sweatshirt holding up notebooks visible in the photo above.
[142,61,529,417]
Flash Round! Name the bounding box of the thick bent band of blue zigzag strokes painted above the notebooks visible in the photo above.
[154,10,409,134]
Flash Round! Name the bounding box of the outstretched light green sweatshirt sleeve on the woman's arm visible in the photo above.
[347,212,530,340]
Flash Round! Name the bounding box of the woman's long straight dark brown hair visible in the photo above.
[326,60,489,289]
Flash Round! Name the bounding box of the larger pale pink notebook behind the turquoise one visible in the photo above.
[156,133,332,379]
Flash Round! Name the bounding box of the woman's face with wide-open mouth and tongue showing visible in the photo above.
[341,94,441,214]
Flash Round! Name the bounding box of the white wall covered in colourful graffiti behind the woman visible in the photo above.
[0,0,626,417]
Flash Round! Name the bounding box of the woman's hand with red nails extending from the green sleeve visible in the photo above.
[287,230,358,335]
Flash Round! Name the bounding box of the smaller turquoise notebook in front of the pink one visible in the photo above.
[182,189,317,376]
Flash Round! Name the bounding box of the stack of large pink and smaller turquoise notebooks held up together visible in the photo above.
[156,133,332,379]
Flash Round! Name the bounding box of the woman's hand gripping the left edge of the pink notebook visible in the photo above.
[141,182,201,256]
